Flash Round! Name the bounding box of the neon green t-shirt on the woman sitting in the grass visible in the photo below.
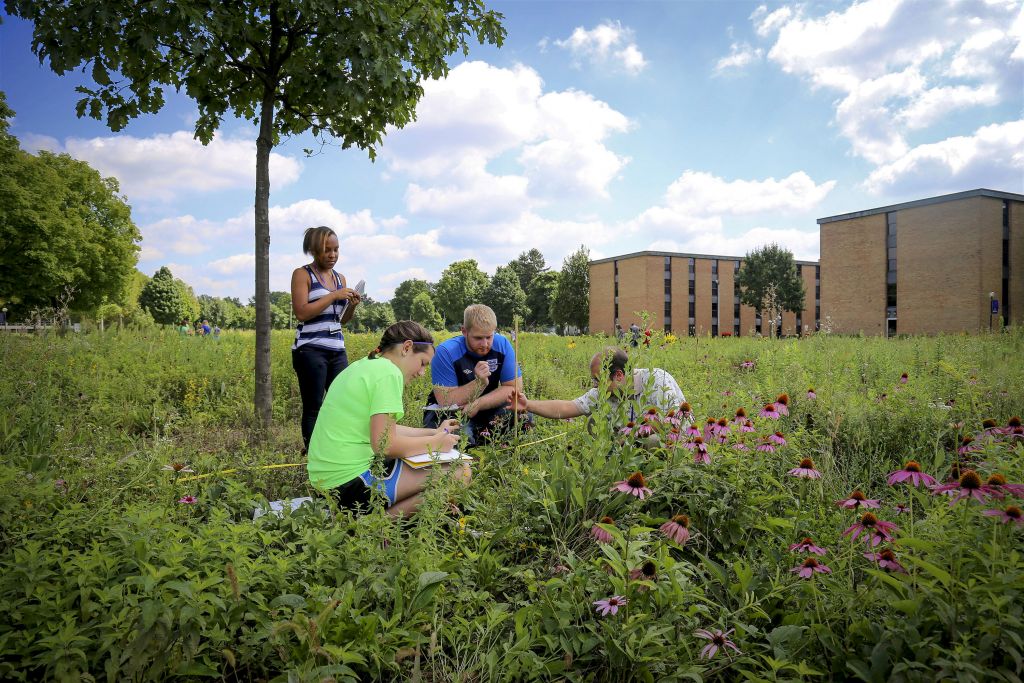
[306,358,404,488]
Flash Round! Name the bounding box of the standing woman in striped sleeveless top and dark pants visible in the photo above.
[292,225,359,449]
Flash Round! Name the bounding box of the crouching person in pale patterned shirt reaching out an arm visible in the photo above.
[509,346,686,429]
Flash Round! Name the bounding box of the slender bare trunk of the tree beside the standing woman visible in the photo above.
[254,88,273,429]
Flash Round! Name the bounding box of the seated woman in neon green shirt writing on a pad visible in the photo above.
[306,321,471,515]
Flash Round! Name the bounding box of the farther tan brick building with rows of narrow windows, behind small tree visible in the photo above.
[590,251,819,337]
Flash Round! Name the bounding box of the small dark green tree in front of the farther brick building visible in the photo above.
[736,244,804,323]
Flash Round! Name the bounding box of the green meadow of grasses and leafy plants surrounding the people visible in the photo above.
[0,331,1024,681]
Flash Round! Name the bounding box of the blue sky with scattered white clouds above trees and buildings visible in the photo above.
[0,0,1024,300]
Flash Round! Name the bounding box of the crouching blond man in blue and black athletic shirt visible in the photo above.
[423,303,522,445]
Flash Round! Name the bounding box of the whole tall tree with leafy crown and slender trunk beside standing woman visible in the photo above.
[5,0,505,425]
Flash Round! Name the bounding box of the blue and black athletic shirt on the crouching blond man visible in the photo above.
[427,333,522,424]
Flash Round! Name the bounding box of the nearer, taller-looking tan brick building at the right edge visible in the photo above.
[818,189,1024,336]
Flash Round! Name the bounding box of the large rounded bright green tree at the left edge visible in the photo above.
[0,93,140,315]
